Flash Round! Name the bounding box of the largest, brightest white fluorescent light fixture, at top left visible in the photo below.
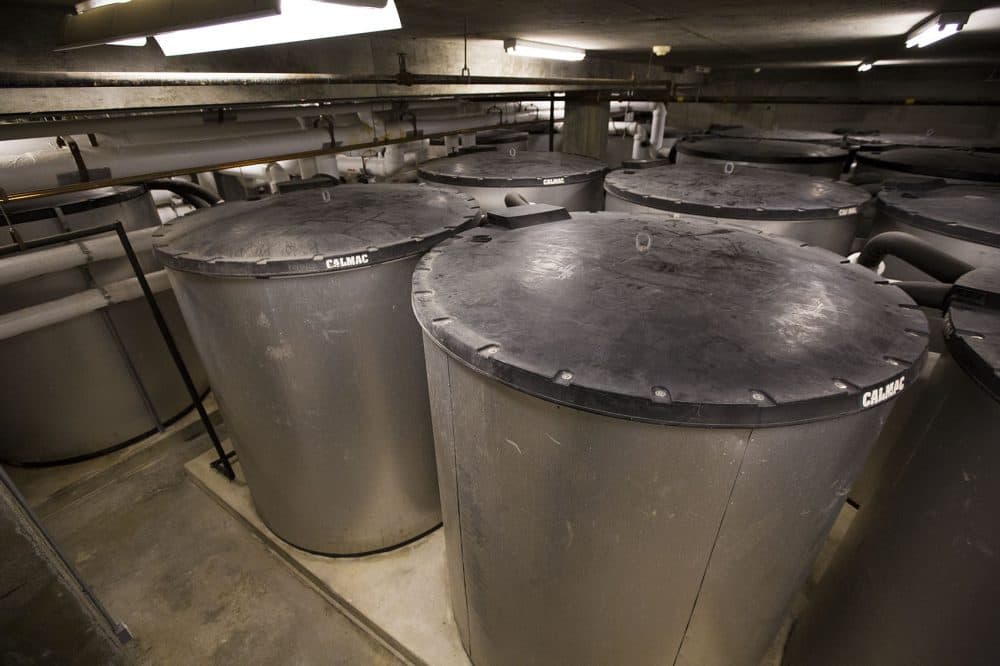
[155,0,402,56]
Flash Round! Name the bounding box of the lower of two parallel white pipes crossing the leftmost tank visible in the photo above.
[0,270,170,340]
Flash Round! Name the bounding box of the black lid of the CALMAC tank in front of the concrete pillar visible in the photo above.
[417,150,607,187]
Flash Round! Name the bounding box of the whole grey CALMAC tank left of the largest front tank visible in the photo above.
[154,185,479,555]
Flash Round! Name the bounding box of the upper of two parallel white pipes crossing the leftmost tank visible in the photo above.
[0,227,160,285]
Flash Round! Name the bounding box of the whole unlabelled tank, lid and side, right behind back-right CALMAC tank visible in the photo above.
[674,136,848,179]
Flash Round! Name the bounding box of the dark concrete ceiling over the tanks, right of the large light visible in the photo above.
[11,0,1000,67]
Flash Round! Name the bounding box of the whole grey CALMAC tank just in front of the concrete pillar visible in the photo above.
[417,150,607,210]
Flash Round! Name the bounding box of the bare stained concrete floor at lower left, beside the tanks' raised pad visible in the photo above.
[8,412,401,665]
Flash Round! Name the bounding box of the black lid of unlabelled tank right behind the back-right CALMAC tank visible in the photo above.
[675,137,848,164]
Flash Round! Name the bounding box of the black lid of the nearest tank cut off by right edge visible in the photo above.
[944,266,1000,401]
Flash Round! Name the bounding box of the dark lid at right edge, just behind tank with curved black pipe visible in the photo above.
[856,148,1000,183]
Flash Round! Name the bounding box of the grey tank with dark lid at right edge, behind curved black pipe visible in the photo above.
[873,181,1000,280]
